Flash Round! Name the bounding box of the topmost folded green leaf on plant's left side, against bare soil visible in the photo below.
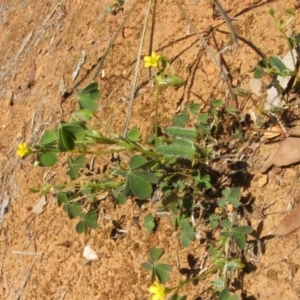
[77,82,100,111]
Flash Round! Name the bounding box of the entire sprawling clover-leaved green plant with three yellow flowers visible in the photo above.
[17,52,252,300]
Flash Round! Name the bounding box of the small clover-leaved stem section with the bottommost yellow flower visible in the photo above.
[142,189,253,300]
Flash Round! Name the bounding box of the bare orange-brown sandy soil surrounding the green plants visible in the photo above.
[0,0,300,300]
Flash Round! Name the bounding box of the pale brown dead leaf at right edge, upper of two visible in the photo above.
[260,127,300,173]
